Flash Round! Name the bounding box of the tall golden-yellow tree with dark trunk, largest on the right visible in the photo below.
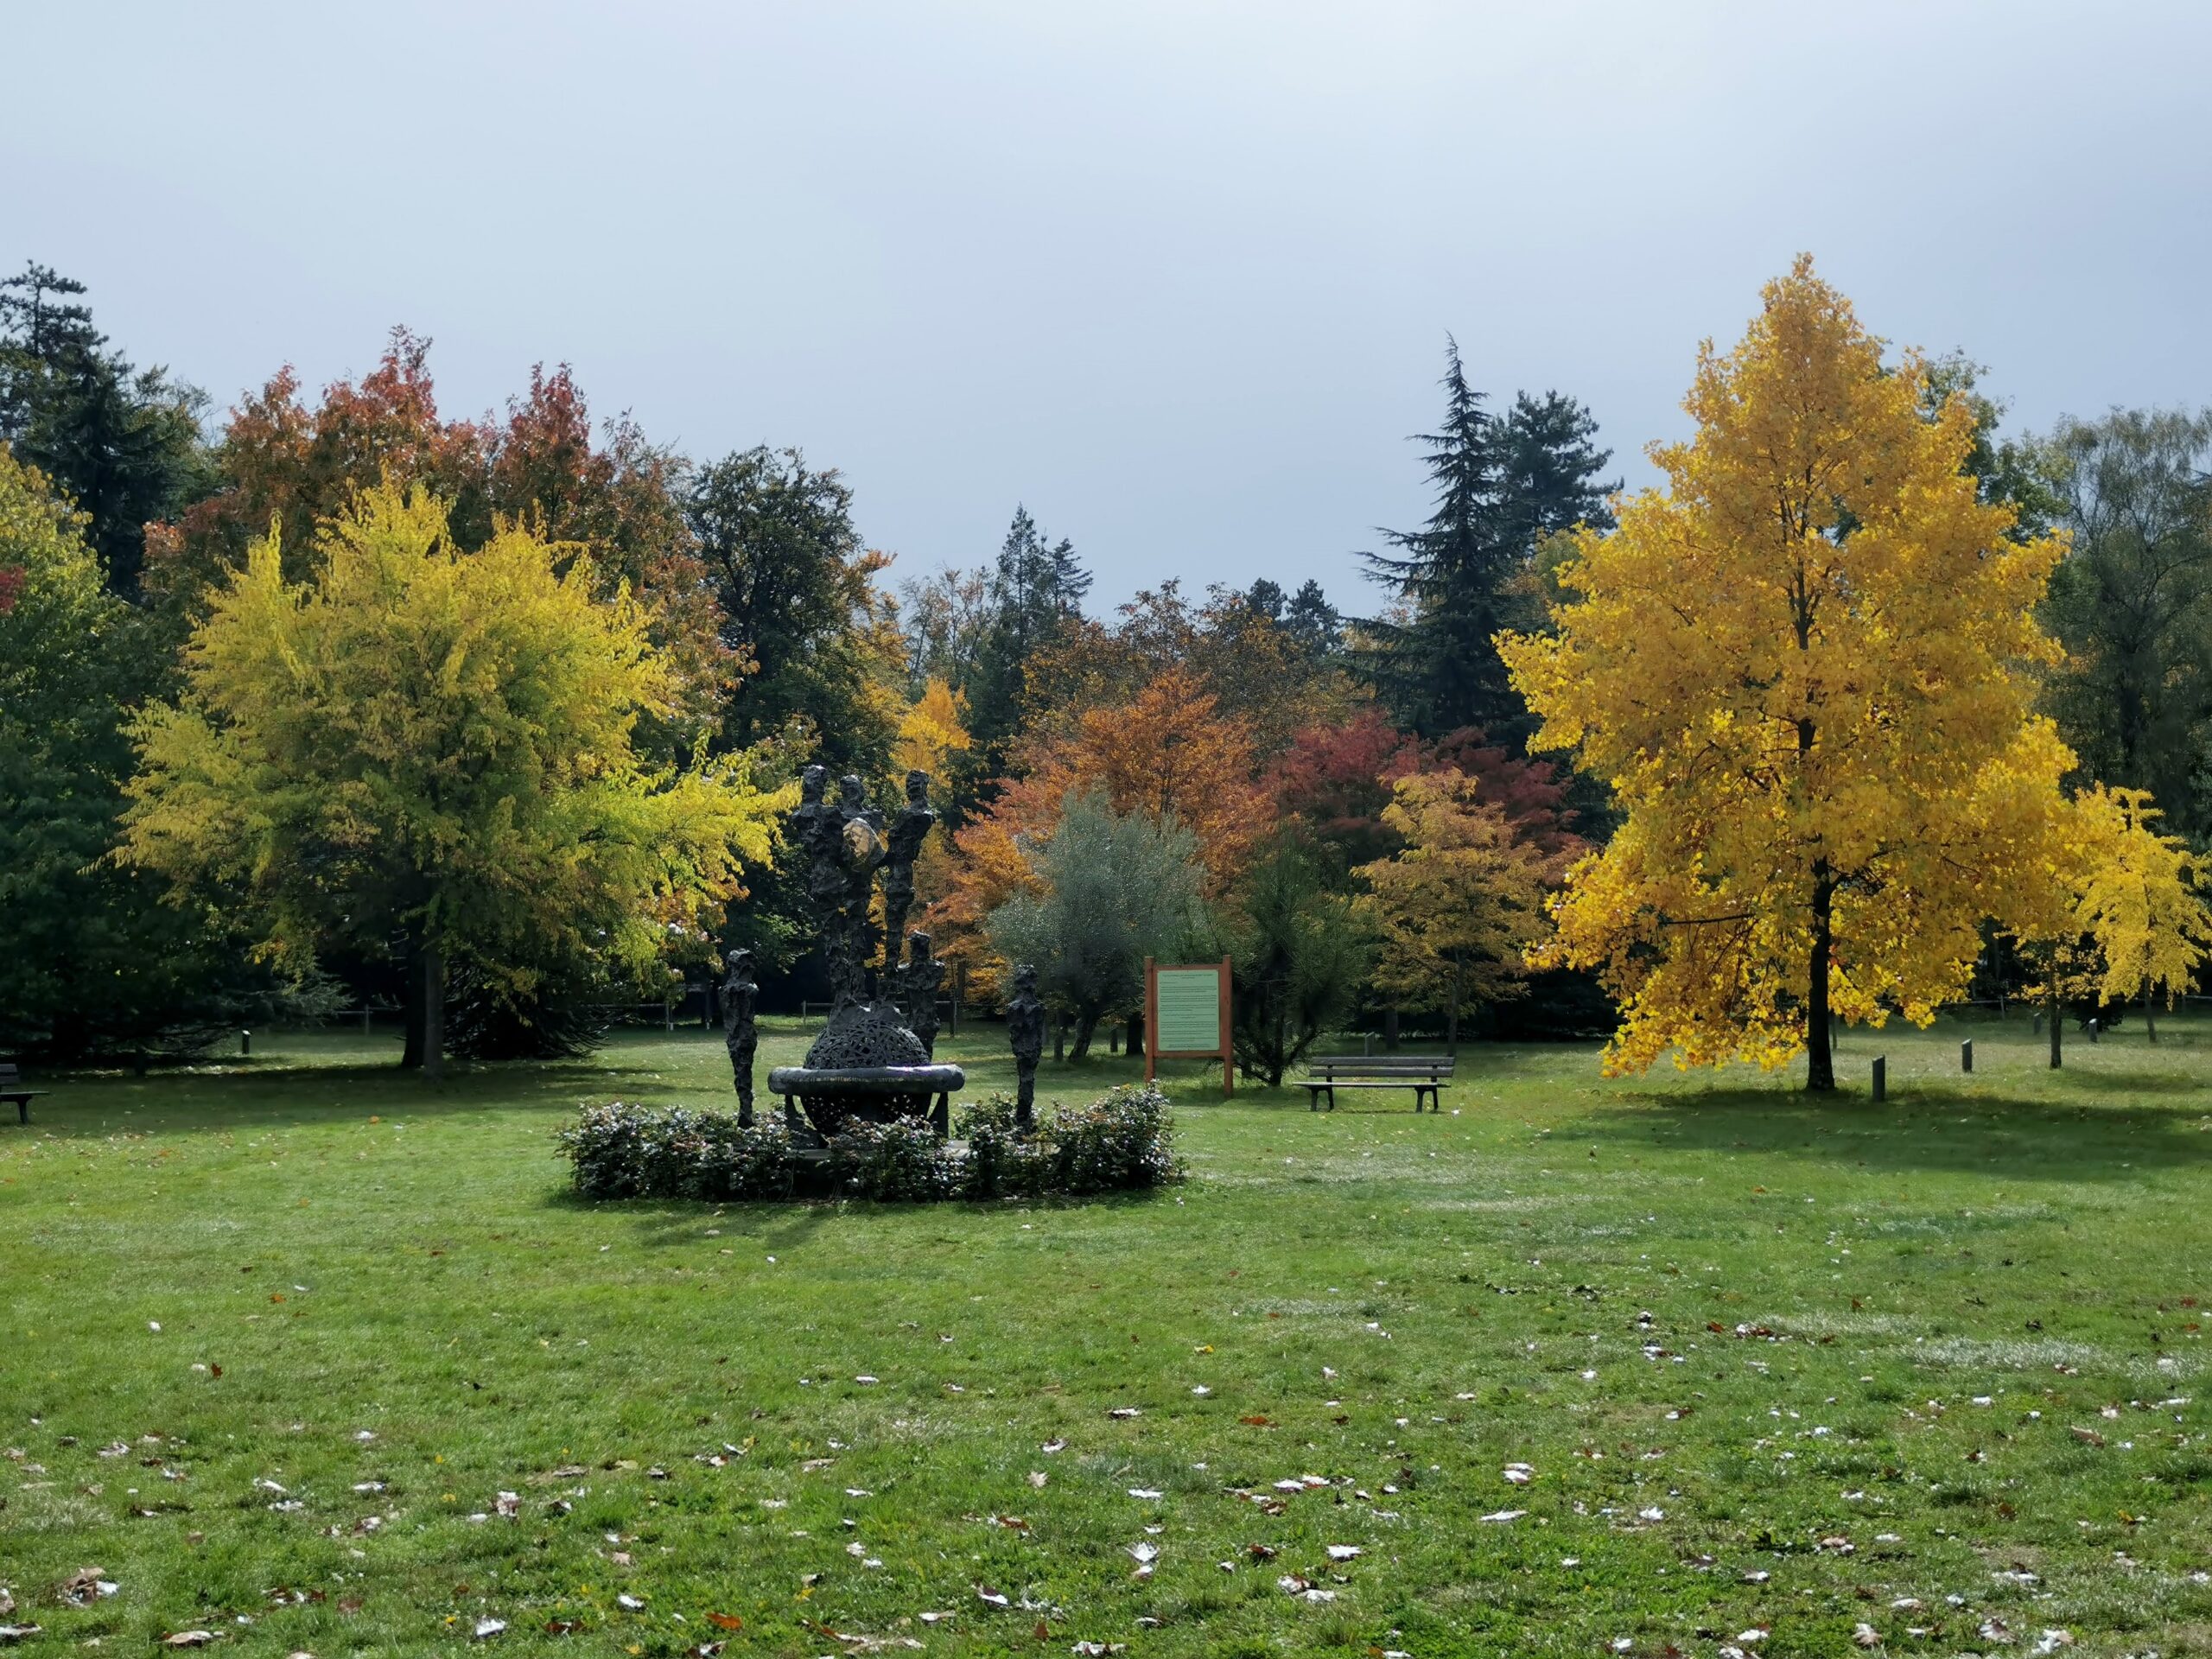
[1500,259,2073,1090]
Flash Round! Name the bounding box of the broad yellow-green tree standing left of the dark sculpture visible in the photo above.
[122,486,785,1075]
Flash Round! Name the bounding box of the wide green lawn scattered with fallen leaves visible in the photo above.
[0,1018,2212,1659]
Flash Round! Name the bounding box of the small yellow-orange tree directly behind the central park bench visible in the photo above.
[1356,772,1551,1051]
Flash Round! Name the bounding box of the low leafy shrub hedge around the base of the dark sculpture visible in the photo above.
[560,1084,1181,1204]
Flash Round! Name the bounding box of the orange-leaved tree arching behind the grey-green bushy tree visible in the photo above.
[931,666,1272,973]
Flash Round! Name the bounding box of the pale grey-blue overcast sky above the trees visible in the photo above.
[0,0,2212,611]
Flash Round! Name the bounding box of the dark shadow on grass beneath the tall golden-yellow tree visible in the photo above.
[1560,1073,2212,1181]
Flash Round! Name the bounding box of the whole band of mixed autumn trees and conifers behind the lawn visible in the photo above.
[0,253,2212,1079]
